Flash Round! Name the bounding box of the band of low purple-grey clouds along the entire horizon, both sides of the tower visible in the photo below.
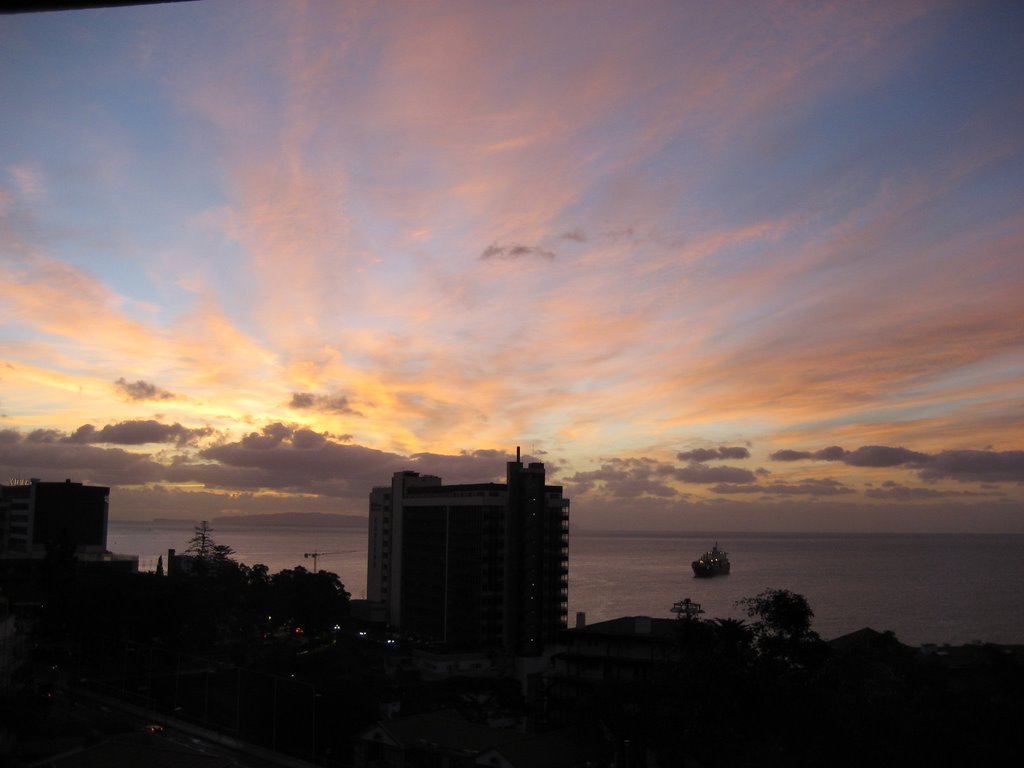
[0,428,1024,527]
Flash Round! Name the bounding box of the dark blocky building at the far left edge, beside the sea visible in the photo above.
[0,478,111,556]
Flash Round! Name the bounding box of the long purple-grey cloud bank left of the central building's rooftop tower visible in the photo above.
[0,421,520,511]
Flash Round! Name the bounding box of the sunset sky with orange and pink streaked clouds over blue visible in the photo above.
[0,0,1024,532]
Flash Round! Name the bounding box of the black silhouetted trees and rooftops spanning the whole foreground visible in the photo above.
[0,529,1024,768]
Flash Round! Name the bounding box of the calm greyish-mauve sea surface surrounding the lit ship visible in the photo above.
[108,522,1024,645]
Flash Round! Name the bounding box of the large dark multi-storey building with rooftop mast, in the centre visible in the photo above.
[367,449,569,655]
